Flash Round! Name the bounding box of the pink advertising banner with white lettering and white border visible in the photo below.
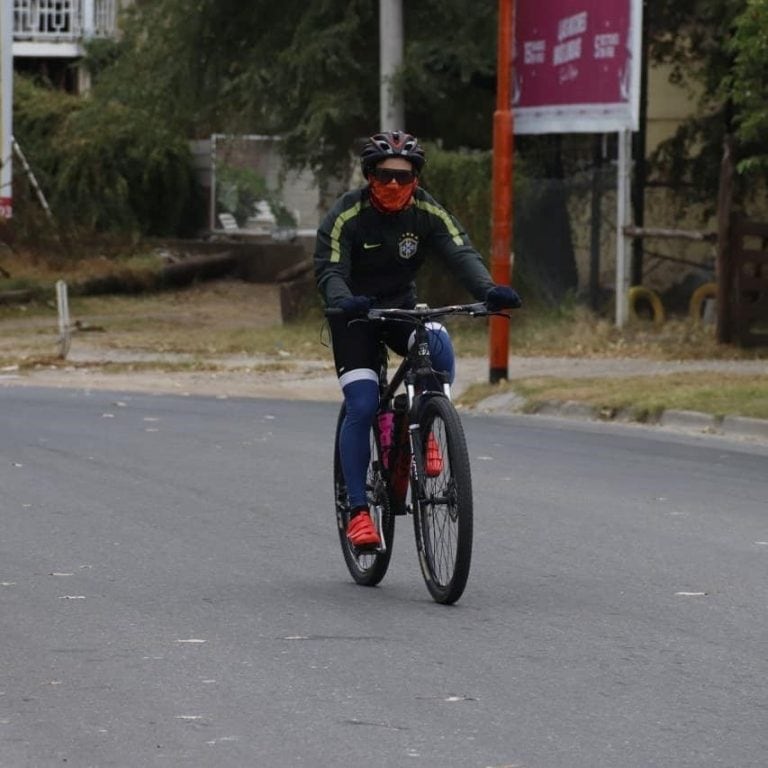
[512,0,642,134]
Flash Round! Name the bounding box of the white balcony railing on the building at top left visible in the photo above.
[13,0,118,42]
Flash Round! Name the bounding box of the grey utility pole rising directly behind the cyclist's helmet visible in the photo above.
[379,0,405,131]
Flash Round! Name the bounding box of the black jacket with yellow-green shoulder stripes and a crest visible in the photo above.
[314,187,494,307]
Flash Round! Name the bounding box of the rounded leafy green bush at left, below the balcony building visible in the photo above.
[14,78,202,240]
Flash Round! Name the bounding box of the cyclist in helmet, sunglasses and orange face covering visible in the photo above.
[314,131,521,548]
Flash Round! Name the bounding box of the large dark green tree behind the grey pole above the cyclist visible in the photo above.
[90,0,496,175]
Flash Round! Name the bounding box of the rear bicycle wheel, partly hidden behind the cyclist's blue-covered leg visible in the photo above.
[333,405,395,587]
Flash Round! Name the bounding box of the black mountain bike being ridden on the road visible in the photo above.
[326,303,504,605]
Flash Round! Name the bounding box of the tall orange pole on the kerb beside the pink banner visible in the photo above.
[489,0,515,384]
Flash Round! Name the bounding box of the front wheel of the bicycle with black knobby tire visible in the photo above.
[412,397,473,605]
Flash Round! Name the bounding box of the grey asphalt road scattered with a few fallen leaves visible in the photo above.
[0,387,768,768]
